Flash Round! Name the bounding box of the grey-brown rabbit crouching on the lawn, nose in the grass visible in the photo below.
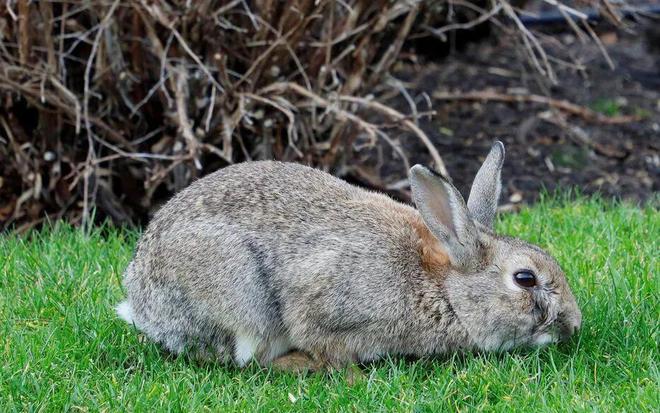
[117,141,581,369]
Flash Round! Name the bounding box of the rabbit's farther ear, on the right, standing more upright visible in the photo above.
[468,141,504,229]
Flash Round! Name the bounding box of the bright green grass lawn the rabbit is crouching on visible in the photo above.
[0,199,660,412]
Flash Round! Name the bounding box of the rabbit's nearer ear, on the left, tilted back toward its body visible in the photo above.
[410,165,478,267]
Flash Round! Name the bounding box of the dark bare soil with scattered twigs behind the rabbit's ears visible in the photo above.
[356,17,660,209]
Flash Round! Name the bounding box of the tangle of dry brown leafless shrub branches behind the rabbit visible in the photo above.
[0,0,635,230]
